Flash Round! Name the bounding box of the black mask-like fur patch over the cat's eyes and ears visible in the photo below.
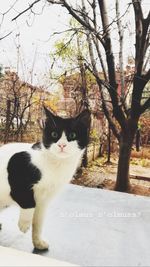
[43,108,90,149]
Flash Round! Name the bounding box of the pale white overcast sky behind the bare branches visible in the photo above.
[0,0,150,90]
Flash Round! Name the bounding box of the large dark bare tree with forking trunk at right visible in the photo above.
[4,0,150,191]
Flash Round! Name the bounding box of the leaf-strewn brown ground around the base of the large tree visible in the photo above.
[72,157,150,196]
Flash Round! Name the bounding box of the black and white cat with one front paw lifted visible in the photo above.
[0,107,91,250]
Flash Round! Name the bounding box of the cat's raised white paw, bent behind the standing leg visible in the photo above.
[18,208,34,233]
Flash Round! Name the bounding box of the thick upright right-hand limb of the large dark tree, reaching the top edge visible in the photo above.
[131,0,150,118]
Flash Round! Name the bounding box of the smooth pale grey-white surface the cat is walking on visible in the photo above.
[0,185,150,266]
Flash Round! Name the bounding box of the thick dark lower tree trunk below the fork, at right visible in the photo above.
[115,136,133,192]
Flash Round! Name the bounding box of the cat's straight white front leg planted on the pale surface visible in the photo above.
[32,202,49,250]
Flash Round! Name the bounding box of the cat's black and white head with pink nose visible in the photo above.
[43,107,90,158]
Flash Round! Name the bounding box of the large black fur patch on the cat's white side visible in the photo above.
[7,152,41,209]
